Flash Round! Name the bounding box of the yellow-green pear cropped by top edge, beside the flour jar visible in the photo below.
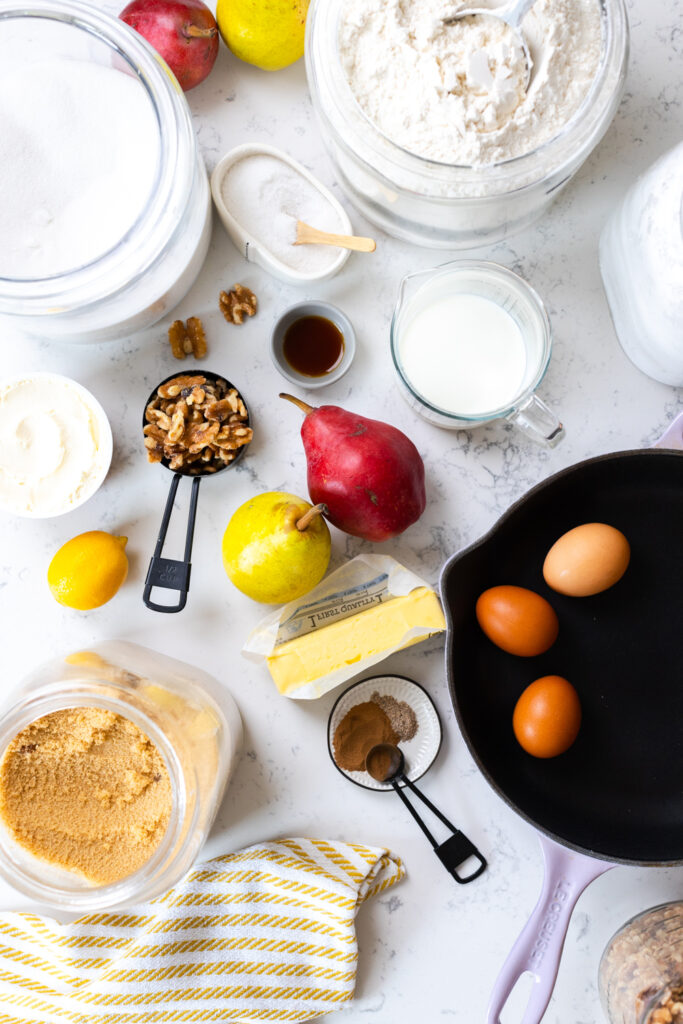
[216,0,308,71]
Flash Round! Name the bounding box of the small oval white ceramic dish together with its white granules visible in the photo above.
[211,143,352,285]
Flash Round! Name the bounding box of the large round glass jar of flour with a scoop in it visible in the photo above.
[306,0,629,249]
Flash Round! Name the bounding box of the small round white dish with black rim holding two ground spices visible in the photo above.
[328,676,441,793]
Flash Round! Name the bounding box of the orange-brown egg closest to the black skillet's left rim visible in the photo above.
[476,587,560,657]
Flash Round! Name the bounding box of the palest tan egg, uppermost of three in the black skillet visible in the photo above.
[543,522,631,597]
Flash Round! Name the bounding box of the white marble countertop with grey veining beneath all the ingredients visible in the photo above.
[0,0,683,1024]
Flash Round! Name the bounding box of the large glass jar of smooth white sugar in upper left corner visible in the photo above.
[0,0,211,342]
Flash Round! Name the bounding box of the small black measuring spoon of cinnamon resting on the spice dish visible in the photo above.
[365,742,486,885]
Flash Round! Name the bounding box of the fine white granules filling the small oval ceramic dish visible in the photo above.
[220,154,344,273]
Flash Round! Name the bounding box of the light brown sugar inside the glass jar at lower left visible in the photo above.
[0,708,172,885]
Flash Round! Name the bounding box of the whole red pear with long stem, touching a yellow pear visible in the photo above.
[280,394,426,541]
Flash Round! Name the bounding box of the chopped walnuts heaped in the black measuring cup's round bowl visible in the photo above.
[142,370,254,476]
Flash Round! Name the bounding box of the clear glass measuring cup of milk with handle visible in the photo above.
[391,260,563,446]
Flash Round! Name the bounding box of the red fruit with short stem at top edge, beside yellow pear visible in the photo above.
[119,0,218,92]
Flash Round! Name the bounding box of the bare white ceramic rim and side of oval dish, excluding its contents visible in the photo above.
[211,142,353,285]
